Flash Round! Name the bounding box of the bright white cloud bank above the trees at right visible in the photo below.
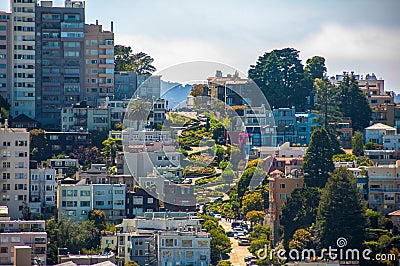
[295,24,400,91]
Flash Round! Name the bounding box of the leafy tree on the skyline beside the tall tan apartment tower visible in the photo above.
[114,45,156,76]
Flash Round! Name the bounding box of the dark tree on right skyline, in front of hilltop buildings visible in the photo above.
[338,74,372,131]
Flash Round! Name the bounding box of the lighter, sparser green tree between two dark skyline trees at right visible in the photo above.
[314,78,341,130]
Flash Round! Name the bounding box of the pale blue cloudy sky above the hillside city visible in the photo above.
[0,0,400,92]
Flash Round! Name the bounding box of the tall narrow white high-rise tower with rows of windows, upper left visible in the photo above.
[11,0,37,118]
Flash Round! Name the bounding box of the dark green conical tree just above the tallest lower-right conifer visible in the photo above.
[303,128,334,188]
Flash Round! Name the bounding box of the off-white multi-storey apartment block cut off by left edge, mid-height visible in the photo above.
[0,121,29,219]
